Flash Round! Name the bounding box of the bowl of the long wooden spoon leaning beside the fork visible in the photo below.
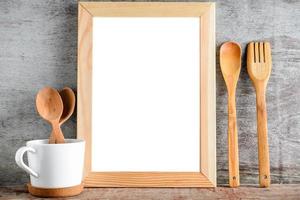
[220,42,242,86]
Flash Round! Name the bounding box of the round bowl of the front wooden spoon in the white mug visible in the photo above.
[36,87,63,123]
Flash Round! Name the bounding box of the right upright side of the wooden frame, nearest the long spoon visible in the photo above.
[200,4,217,184]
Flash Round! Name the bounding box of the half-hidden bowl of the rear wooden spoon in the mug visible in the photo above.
[59,87,76,124]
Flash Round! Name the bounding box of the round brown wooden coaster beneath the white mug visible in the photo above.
[27,183,83,197]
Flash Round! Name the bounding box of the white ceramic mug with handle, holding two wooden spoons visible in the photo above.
[15,139,85,188]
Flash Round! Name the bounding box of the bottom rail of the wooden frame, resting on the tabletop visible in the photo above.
[84,172,215,188]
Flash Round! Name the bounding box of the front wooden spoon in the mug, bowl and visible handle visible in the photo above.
[36,87,65,143]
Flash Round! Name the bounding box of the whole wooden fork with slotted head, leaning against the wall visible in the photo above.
[247,42,272,187]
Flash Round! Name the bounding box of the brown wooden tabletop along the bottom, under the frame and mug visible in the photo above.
[0,184,300,200]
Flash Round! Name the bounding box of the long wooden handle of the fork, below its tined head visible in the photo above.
[256,91,271,187]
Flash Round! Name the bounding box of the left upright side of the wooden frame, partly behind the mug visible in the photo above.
[77,2,93,177]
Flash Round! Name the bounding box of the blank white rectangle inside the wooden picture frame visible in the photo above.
[92,17,200,172]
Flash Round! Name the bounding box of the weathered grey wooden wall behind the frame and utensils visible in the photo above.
[0,0,300,186]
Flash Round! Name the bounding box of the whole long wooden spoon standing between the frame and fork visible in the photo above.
[220,42,241,187]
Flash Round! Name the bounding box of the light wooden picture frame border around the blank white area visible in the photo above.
[77,2,216,187]
